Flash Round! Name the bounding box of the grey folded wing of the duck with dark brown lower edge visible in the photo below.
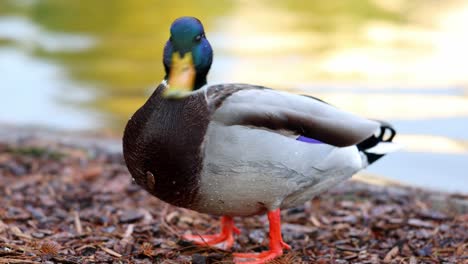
[208,84,380,147]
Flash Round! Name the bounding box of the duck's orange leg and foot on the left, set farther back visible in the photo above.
[182,216,240,250]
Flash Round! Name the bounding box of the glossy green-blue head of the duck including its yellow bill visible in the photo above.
[163,17,213,97]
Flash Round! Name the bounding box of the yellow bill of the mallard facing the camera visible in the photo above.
[163,52,196,99]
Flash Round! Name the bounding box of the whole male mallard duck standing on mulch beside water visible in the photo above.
[123,17,395,263]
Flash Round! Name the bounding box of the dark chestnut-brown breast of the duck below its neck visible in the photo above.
[123,84,210,208]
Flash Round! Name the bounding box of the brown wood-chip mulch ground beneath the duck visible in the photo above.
[0,140,468,264]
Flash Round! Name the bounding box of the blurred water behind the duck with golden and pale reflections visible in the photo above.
[0,0,468,193]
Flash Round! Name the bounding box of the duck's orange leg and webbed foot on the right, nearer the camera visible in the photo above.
[233,208,291,264]
